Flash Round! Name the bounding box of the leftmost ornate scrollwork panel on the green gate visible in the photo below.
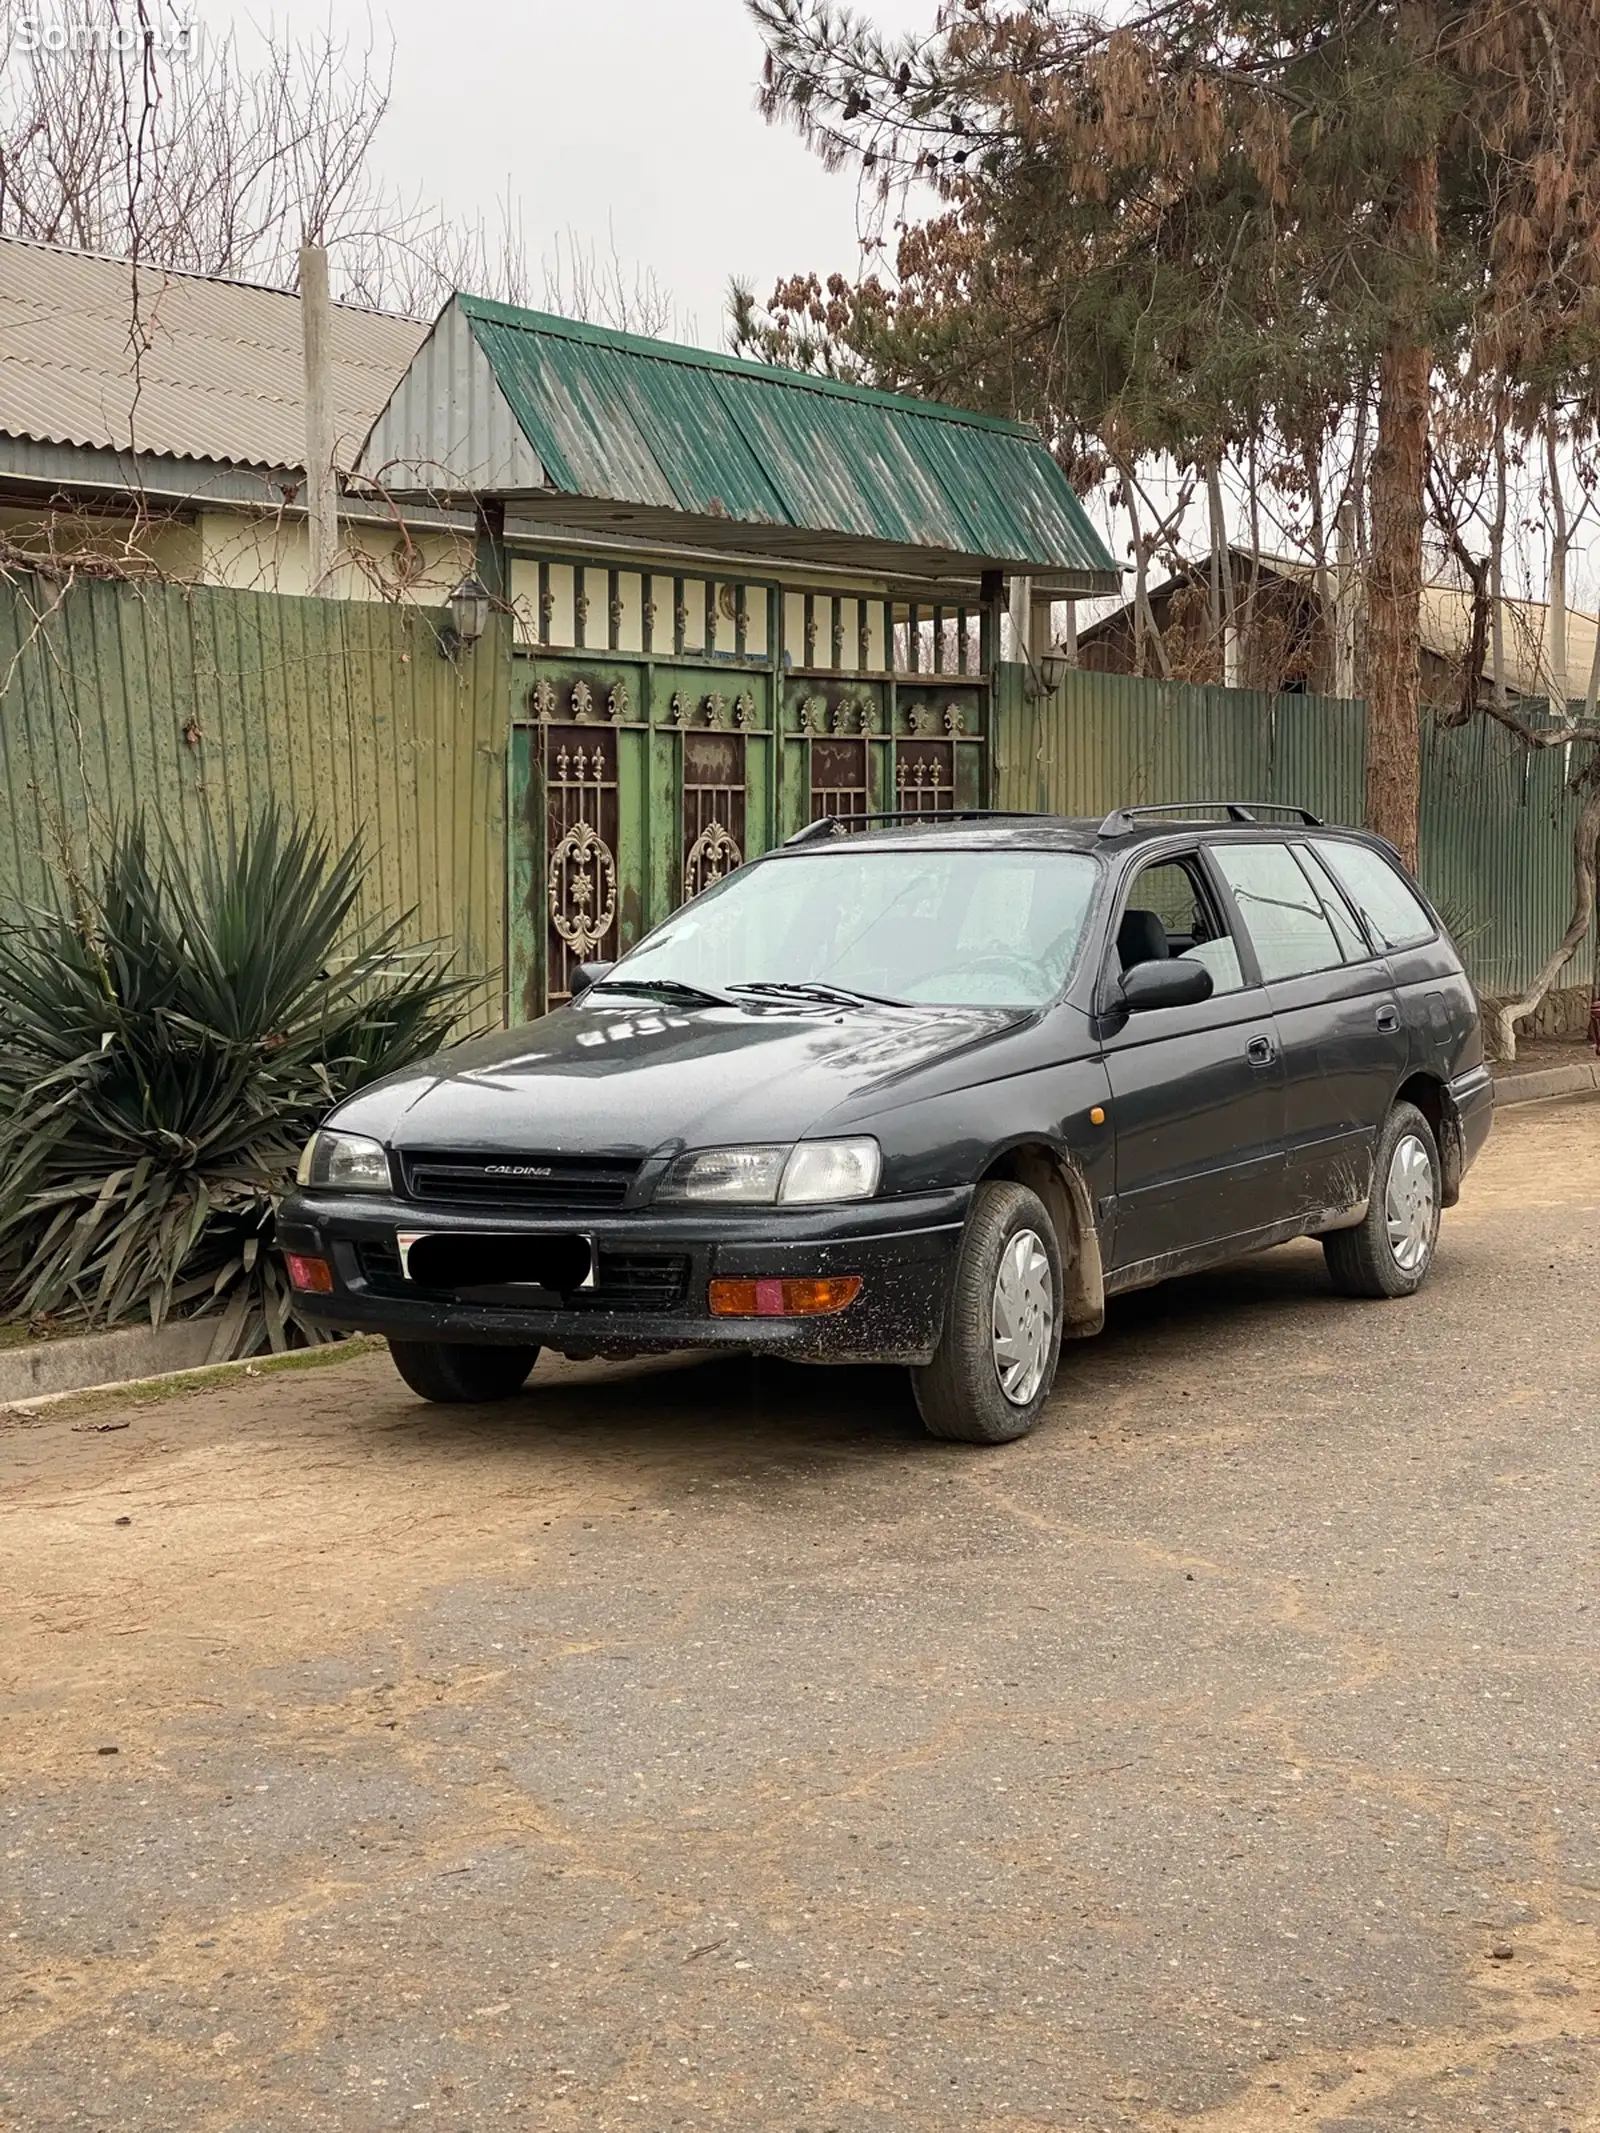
[544,725,621,1000]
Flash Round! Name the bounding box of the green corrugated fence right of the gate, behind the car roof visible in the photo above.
[994,665,1594,996]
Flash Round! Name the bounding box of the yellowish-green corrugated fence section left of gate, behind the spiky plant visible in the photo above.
[0,578,510,1024]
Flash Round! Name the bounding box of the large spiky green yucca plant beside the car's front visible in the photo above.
[0,808,474,1359]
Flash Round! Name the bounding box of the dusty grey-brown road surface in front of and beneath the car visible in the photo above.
[0,1098,1600,2133]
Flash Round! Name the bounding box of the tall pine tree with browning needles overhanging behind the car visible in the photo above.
[749,0,1600,862]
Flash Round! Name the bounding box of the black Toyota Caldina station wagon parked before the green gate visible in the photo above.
[282,802,1493,1444]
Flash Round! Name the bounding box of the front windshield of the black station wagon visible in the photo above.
[606,847,1099,1009]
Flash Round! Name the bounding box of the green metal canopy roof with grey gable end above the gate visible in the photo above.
[358,296,1120,593]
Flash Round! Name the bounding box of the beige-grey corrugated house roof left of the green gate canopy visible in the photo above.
[0,239,429,469]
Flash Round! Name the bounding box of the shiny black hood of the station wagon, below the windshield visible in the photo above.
[333,994,1037,1156]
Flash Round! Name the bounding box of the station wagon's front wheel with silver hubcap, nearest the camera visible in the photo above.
[911,1180,1062,1444]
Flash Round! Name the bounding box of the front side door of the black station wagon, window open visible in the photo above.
[1099,849,1284,1278]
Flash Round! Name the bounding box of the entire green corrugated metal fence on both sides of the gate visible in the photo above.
[0,578,1594,1022]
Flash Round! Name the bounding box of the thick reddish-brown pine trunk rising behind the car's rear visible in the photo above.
[1367,156,1438,868]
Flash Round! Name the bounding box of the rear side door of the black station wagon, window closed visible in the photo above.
[1210,838,1406,1229]
